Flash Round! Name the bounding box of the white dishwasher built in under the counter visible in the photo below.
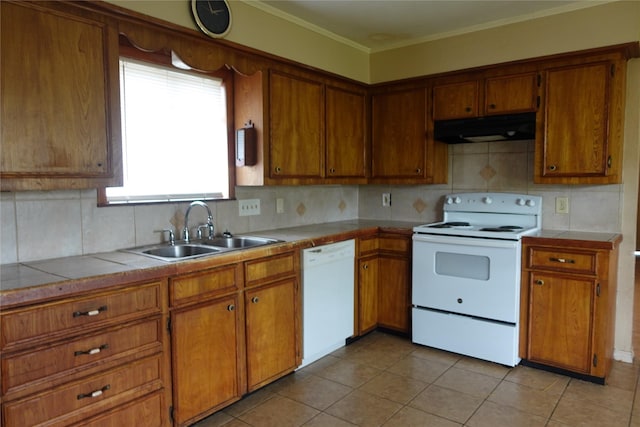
[300,240,355,367]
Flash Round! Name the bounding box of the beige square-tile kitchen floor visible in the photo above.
[196,332,640,427]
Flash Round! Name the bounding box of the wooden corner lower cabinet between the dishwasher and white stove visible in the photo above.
[356,232,411,335]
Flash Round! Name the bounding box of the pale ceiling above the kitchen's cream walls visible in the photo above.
[255,0,610,52]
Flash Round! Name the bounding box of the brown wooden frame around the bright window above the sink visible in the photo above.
[97,36,236,207]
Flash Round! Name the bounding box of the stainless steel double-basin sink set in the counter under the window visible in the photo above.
[122,236,280,261]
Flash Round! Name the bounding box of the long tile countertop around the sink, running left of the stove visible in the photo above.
[0,220,418,308]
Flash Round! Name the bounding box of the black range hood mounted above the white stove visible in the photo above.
[433,113,536,144]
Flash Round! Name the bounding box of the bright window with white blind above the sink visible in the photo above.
[104,54,233,204]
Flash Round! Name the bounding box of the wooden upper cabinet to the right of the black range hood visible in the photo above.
[534,58,626,184]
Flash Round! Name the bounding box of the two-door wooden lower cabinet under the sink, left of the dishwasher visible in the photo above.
[169,252,301,426]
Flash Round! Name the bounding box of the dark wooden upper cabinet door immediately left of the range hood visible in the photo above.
[372,89,427,179]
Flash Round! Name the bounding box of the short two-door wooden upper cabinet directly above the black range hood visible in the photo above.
[433,72,538,120]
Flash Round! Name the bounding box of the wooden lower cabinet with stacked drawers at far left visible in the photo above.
[0,280,171,427]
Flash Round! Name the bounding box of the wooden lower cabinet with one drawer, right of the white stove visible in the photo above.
[520,237,620,383]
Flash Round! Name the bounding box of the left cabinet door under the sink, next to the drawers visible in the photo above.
[171,295,241,425]
